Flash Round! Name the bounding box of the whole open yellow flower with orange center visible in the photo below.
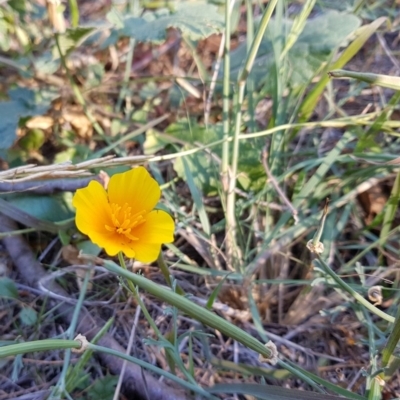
[72,167,174,262]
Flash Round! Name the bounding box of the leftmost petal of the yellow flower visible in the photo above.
[72,181,112,236]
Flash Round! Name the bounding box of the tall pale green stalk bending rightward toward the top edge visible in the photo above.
[226,0,278,270]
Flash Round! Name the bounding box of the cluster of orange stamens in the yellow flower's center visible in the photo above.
[106,203,146,240]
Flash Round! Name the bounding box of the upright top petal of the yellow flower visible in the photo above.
[108,167,161,213]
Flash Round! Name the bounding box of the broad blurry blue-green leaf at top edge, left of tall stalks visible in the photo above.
[121,2,224,43]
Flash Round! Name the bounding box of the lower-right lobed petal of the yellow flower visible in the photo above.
[129,210,175,262]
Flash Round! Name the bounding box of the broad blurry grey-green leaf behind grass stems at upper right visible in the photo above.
[227,10,360,90]
